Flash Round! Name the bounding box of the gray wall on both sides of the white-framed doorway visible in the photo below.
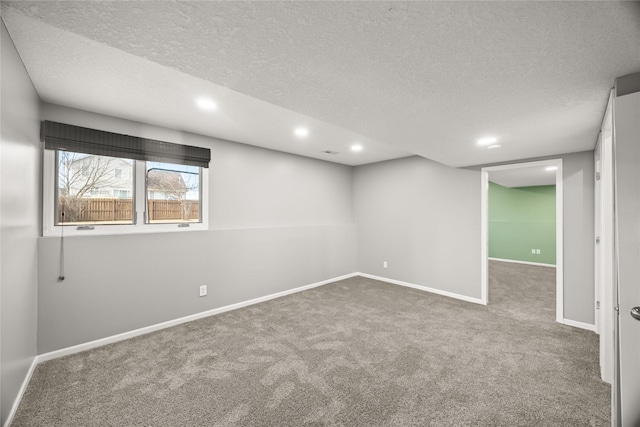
[353,151,595,324]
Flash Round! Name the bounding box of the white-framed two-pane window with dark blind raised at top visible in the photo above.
[43,122,210,235]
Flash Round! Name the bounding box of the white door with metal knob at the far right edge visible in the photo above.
[613,88,640,427]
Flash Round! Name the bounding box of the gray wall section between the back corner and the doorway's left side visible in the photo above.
[353,157,481,298]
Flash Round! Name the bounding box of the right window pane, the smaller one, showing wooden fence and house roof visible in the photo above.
[146,162,202,224]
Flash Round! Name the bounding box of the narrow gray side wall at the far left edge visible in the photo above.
[0,23,40,424]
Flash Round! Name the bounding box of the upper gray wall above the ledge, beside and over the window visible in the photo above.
[43,104,353,228]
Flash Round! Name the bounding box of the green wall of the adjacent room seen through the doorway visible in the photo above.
[489,182,556,265]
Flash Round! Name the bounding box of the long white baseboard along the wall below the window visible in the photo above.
[37,273,358,363]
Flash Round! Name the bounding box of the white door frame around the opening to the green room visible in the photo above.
[480,159,566,323]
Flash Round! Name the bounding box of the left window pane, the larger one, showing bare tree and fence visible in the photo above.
[56,151,134,225]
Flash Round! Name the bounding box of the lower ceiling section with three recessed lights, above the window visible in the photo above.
[4,8,410,165]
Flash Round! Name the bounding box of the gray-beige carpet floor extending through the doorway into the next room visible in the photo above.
[12,262,610,427]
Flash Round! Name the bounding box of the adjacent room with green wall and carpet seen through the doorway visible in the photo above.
[487,160,564,320]
